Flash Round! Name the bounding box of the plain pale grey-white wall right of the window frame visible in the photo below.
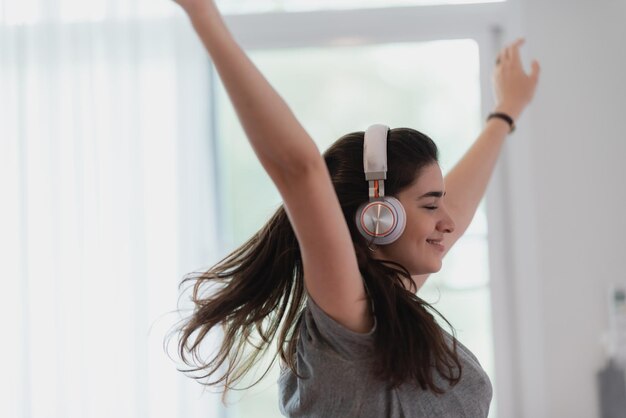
[516,0,626,418]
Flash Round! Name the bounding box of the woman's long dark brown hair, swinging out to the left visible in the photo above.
[168,128,461,393]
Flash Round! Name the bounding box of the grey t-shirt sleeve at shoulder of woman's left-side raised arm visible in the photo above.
[301,297,377,360]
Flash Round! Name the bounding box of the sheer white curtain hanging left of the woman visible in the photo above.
[0,0,223,418]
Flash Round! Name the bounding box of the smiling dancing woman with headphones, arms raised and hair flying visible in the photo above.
[168,0,539,417]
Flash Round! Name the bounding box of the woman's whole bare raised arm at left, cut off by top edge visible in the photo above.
[176,0,373,332]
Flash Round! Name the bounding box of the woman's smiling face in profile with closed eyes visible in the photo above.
[375,163,455,275]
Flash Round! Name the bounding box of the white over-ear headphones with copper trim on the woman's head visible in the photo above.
[355,124,406,245]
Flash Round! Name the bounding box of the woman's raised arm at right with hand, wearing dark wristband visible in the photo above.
[414,39,540,283]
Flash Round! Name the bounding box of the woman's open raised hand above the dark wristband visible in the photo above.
[493,38,540,119]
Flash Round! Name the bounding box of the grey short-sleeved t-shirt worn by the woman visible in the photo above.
[278,298,492,418]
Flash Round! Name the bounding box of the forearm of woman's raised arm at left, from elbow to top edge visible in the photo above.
[177,0,320,179]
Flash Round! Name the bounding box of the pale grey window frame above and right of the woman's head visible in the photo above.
[211,0,524,418]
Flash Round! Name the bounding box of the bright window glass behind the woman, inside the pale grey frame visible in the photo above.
[212,39,495,418]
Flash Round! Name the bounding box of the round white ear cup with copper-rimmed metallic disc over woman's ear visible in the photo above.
[355,197,406,245]
